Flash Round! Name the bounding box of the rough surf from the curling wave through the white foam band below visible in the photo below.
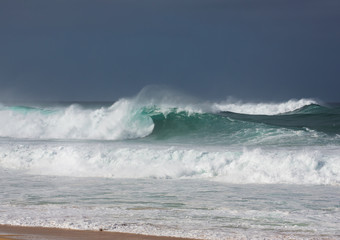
[0,89,340,185]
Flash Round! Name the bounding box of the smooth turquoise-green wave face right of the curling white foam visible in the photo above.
[144,105,340,145]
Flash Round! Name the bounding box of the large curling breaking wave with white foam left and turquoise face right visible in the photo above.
[0,91,340,144]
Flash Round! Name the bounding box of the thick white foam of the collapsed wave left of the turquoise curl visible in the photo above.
[0,99,153,140]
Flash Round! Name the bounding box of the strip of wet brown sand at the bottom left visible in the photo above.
[0,225,197,240]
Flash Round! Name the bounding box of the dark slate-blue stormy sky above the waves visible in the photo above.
[0,0,340,102]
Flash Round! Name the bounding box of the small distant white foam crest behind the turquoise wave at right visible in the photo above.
[212,99,317,115]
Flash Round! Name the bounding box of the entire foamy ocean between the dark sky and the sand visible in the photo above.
[0,89,340,239]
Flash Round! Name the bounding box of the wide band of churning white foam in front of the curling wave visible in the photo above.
[0,142,340,185]
